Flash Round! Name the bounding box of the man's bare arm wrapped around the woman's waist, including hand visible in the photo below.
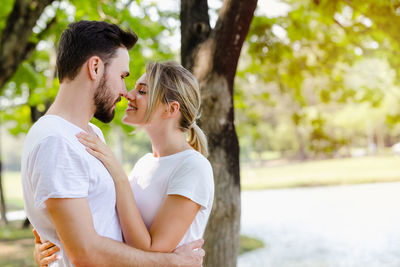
[46,198,204,267]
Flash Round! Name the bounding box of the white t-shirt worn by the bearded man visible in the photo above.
[21,115,122,266]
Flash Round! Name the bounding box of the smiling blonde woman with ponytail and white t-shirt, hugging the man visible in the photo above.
[35,62,214,266]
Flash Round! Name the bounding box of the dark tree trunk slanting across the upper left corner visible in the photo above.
[0,0,55,92]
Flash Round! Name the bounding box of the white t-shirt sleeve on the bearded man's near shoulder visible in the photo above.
[31,136,89,208]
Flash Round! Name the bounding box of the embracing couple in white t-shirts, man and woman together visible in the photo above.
[21,21,214,266]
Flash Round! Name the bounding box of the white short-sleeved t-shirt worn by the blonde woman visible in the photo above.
[129,149,214,246]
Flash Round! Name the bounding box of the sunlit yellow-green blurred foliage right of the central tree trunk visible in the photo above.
[234,0,400,160]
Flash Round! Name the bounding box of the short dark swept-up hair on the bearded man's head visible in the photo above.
[57,20,138,82]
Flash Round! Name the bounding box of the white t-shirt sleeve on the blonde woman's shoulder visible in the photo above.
[167,157,214,209]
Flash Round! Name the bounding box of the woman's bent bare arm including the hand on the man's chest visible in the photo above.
[77,133,200,252]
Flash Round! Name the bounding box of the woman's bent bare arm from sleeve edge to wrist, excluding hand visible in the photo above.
[116,179,200,252]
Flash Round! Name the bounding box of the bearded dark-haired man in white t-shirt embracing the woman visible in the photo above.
[21,21,204,266]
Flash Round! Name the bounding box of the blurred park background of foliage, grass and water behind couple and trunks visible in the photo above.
[0,0,400,267]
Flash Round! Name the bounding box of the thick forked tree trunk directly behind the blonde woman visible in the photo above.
[180,0,257,267]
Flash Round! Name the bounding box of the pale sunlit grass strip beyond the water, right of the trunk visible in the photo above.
[241,156,400,190]
